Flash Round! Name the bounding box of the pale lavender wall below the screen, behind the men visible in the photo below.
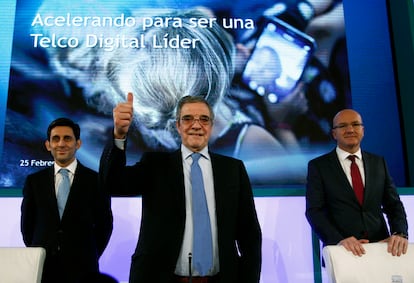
[0,196,414,283]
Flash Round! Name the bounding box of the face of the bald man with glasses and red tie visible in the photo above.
[332,109,364,153]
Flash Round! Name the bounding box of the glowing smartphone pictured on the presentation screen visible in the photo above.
[242,17,316,103]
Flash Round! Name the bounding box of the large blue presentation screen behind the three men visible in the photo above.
[0,0,404,190]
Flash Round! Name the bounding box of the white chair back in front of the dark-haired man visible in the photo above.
[0,247,46,283]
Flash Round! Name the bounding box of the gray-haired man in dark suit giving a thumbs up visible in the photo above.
[100,93,262,283]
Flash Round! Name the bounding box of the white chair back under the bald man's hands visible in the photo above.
[322,243,414,283]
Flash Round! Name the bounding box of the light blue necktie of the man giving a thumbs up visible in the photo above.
[191,153,213,276]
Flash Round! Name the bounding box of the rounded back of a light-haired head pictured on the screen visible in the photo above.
[108,10,235,147]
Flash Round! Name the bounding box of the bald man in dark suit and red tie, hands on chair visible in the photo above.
[306,109,408,256]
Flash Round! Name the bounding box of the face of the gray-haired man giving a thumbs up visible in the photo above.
[176,102,213,152]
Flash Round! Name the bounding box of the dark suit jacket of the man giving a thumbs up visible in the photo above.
[100,142,261,283]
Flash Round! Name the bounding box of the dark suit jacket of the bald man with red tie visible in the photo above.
[306,150,408,245]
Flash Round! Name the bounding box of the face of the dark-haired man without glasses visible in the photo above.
[45,126,81,167]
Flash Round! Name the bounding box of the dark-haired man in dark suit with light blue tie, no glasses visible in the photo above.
[21,118,112,283]
